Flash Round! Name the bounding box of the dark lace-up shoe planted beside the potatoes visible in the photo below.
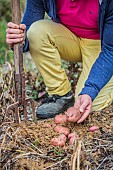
[36,91,74,119]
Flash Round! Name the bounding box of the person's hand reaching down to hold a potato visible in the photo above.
[74,94,92,123]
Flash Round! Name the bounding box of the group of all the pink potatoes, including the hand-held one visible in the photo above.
[50,105,99,147]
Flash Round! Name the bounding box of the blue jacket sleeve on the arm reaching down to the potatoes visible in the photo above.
[79,1,113,100]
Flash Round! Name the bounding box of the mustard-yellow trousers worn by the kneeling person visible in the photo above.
[27,20,113,111]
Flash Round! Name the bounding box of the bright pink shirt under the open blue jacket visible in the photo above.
[56,0,100,39]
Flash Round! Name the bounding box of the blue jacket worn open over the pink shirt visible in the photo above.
[22,0,113,100]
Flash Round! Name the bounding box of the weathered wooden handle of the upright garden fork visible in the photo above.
[11,0,25,105]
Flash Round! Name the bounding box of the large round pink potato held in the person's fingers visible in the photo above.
[66,105,82,122]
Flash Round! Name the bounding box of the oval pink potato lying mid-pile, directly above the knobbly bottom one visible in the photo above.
[54,125,70,136]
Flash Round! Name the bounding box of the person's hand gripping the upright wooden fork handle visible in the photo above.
[6,22,26,47]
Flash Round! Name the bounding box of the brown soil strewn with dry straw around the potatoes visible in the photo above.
[0,104,113,170]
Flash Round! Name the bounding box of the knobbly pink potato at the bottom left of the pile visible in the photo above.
[50,134,66,146]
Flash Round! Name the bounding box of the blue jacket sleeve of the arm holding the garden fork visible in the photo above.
[21,0,45,52]
